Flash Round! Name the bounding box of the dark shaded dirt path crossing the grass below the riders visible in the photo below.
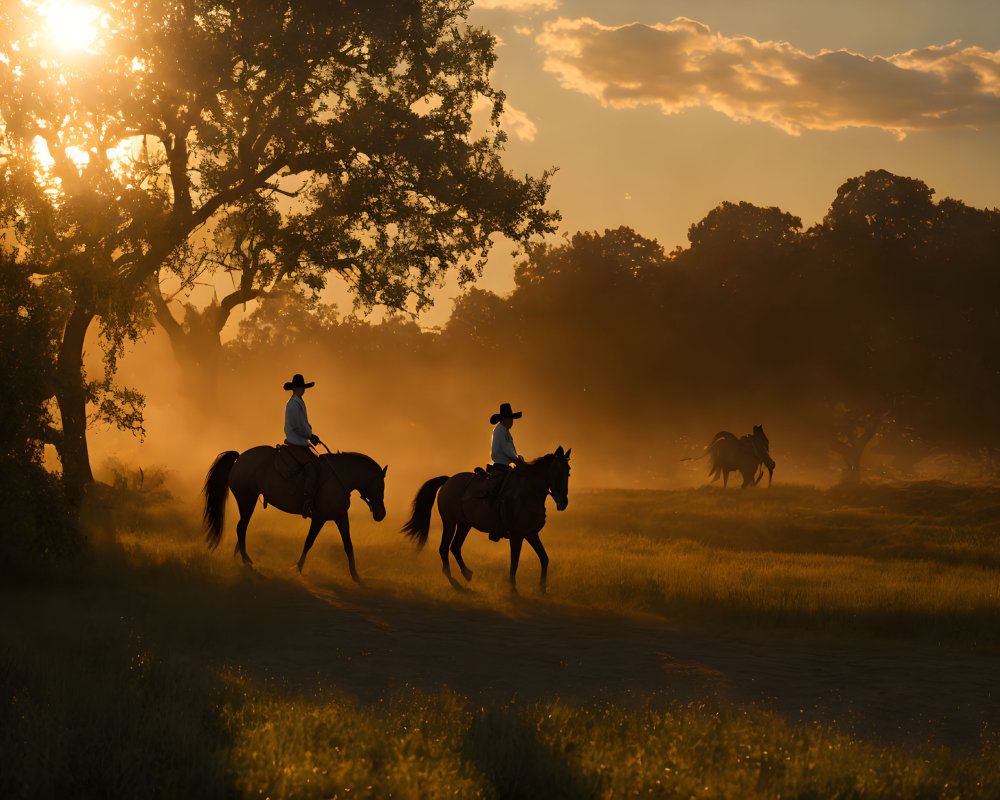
[180,568,1000,748]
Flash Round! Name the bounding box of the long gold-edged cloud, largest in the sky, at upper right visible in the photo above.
[536,17,1000,137]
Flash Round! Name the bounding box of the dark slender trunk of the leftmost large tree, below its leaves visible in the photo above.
[56,305,94,498]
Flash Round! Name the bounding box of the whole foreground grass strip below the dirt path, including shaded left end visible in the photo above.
[0,628,1000,798]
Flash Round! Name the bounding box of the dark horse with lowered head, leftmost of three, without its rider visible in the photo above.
[204,445,389,583]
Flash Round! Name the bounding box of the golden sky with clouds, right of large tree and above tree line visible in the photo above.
[376,0,1000,324]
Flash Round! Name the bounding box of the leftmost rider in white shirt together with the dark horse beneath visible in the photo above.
[204,375,389,581]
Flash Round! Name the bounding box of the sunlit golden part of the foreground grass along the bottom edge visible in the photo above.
[229,693,1000,798]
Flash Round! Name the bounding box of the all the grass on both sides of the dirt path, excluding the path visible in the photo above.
[0,478,1000,798]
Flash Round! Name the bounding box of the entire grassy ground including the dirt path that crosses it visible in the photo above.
[0,484,1000,798]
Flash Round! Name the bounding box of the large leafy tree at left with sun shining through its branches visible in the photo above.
[0,0,555,484]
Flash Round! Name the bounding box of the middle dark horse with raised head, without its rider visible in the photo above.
[403,445,572,593]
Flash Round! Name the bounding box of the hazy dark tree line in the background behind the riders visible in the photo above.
[219,170,1000,485]
